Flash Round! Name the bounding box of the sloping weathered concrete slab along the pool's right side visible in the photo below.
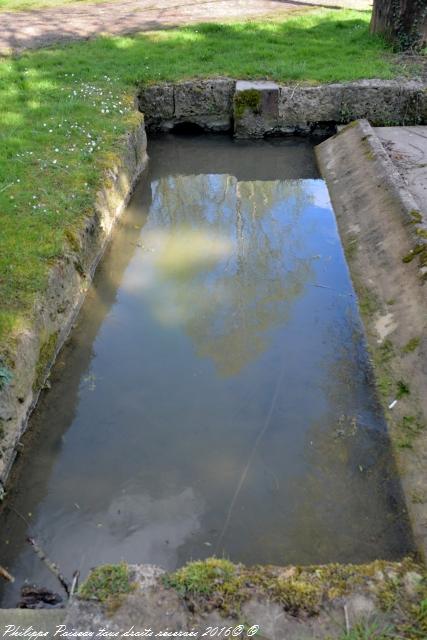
[315,120,427,561]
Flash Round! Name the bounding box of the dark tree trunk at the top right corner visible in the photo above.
[371,0,427,50]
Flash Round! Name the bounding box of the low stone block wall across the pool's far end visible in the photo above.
[136,78,427,138]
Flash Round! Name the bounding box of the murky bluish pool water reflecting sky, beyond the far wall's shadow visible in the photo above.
[1,142,410,604]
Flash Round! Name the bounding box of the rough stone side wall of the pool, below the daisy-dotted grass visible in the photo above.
[0,116,148,499]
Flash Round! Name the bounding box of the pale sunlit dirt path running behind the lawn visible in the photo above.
[0,0,369,55]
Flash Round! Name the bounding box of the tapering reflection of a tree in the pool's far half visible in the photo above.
[145,175,311,376]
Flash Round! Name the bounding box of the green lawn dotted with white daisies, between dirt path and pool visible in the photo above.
[0,10,418,364]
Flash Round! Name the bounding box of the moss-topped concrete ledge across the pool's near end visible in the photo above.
[64,558,425,640]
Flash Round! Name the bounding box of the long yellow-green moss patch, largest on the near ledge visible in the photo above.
[163,558,420,616]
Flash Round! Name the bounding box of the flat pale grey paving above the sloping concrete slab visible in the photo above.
[375,126,427,216]
